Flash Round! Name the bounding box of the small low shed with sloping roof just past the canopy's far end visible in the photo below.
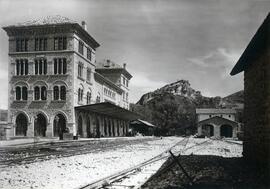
[130,119,157,136]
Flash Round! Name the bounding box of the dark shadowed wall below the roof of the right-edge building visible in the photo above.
[243,50,270,171]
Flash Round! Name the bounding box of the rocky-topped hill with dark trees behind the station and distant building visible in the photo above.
[131,80,243,134]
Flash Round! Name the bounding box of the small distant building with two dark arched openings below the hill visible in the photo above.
[196,109,239,138]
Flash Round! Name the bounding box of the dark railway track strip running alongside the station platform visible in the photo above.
[0,138,156,168]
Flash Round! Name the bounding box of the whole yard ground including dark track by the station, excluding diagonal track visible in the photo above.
[0,137,242,189]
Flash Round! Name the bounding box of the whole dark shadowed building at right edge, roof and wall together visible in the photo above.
[231,11,270,171]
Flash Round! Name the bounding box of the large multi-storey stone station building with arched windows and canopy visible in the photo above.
[3,16,137,138]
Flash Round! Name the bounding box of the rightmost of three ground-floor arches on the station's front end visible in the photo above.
[53,113,67,140]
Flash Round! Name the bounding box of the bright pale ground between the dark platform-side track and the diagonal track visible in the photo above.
[0,137,242,189]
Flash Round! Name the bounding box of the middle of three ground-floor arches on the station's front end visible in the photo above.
[34,113,48,137]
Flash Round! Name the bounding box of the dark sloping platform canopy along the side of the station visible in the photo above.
[75,102,140,121]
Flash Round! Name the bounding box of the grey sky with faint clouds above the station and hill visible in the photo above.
[0,0,270,108]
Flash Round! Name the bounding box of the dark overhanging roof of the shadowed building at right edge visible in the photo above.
[230,13,270,75]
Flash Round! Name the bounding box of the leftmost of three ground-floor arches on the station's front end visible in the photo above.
[15,113,29,136]
